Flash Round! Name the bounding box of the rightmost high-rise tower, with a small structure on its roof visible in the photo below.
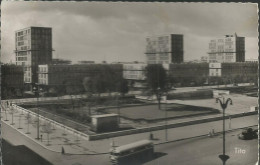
[208,34,245,63]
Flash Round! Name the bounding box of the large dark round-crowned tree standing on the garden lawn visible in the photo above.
[145,64,169,109]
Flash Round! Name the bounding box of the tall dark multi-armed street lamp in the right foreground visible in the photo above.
[216,96,232,165]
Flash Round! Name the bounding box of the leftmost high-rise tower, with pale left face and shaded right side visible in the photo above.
[15,27,53,84]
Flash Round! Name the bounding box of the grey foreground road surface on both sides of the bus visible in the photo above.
[2,121,258,165]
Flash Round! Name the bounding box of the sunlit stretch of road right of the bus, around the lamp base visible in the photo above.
[145,130,258,165]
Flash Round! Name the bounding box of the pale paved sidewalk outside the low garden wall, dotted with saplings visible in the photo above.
[1,100,258,155]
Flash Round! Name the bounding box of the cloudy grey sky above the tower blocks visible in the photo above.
[1,1,258,63]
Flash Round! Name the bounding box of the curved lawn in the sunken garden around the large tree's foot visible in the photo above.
[103,104,219,121]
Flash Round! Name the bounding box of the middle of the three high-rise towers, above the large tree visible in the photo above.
[145,34,183,64]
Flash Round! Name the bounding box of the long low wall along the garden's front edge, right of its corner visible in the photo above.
[88,112,257,141]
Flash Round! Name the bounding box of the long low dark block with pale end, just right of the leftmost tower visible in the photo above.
[38,64,123,89]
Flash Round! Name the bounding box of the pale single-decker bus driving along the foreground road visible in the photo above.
[110,140,154,165]
